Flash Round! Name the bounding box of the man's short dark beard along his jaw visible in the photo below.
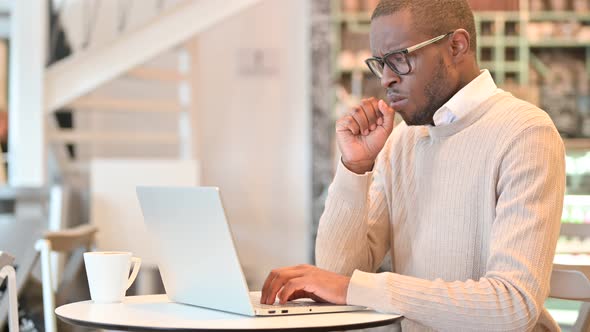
[406,56,452,126]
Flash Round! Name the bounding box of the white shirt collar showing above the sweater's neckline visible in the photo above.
[434,69,503,126]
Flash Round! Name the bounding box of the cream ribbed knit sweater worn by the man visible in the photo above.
[316,92,565,331]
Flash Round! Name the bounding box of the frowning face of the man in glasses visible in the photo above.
[371,10,458,126]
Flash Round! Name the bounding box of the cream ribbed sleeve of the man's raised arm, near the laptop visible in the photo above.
[316,153,391,275]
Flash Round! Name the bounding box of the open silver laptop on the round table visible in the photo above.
[137,186,367,316]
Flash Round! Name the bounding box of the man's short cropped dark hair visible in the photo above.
[371,0,477,52]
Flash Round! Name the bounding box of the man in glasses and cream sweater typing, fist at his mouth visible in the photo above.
[262,0,565,331]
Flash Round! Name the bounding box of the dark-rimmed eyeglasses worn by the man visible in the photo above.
[365,31,455,78]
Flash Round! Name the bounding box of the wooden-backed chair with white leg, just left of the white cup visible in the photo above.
[35,225,97,332]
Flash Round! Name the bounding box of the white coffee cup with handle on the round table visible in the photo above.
[84,251,141,303]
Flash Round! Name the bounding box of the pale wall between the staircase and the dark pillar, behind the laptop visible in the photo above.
[196,0,311,289]
